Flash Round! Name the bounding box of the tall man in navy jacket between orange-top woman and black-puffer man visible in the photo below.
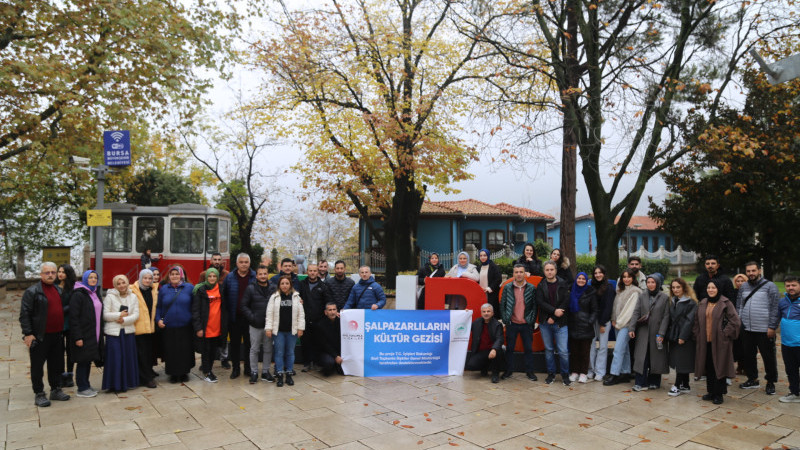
[220,253,256,379]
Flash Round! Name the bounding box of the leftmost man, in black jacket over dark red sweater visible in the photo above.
[19,262,69,407]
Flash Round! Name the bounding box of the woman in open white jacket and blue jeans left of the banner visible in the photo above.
[264,275,306,387]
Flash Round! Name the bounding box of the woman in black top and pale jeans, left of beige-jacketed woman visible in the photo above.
[587,264,617,381]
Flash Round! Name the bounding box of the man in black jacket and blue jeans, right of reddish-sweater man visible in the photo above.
[536,261,571,386]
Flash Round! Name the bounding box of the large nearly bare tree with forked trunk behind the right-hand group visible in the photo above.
[482,0,796,278]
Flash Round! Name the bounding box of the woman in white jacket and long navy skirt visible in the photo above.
[103,275,139,392]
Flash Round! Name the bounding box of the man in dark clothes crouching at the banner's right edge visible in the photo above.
[464,303,504,383]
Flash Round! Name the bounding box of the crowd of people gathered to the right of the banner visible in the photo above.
[454,253,800,404]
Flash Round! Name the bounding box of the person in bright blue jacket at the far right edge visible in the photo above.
[778,275,800,403]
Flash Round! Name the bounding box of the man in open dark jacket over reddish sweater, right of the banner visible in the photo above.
[500,263,537,381]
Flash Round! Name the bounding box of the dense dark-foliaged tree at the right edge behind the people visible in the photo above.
[651,71,800,277]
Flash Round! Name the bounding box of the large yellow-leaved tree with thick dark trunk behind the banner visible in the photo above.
[252,0,495,285]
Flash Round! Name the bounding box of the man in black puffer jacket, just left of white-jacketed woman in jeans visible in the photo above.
[242,265,275,384]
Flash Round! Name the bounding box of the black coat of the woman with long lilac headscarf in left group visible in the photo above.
[69,288,103,363]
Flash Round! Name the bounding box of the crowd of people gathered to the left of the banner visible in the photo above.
[19,253,386,407]
